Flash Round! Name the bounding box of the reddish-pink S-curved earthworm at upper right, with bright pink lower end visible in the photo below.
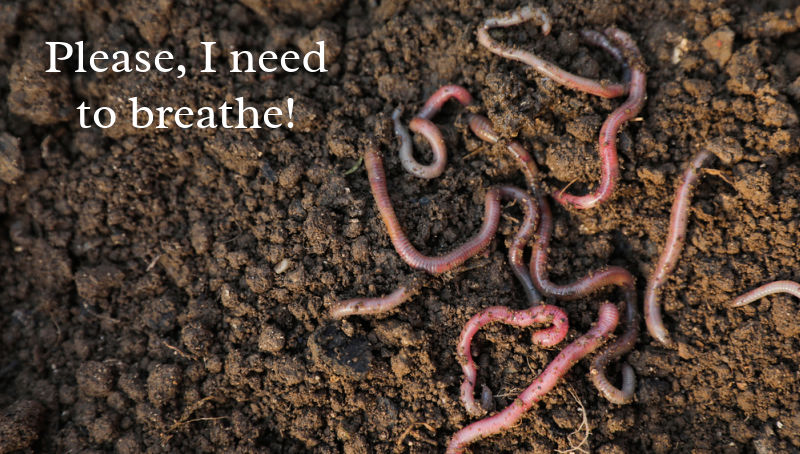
[553,28,647,209]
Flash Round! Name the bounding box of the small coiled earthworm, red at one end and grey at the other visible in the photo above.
[392,85,472,180]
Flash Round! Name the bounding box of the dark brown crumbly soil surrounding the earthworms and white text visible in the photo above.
[0,0,800,454]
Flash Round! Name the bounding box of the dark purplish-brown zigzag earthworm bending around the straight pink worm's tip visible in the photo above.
[530,194,639,405]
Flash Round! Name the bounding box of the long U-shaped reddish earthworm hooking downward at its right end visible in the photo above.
[364,149,537,276]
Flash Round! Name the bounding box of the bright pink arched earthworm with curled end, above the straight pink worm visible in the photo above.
[457,306,569,416]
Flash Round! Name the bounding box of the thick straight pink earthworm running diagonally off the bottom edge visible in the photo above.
[447,303,619,454]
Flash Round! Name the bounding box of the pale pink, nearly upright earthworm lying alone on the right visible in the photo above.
[644,150,714,346]
